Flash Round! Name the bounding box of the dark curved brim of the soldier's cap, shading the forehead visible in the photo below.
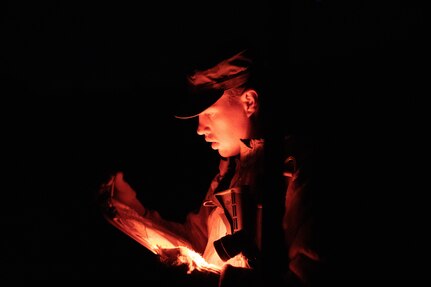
[174,89,224,120]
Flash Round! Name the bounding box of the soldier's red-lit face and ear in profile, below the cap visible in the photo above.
[197,90,257,157]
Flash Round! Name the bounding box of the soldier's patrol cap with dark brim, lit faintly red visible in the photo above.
[175,49,253,119]
